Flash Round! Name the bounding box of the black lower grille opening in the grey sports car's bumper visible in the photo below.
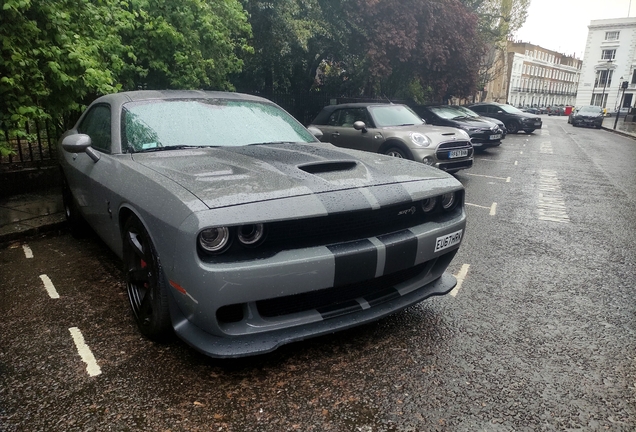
[256,263,430,318]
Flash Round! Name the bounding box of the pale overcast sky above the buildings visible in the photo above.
[515,0,636,59]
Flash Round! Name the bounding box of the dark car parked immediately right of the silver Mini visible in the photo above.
[411,105,505,150]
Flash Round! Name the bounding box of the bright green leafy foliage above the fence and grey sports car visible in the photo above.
[0,0,250,157]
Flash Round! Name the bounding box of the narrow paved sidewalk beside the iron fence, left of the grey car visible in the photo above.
[0,187,66,244]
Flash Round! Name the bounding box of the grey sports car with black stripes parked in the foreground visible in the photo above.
[60,91,466,357]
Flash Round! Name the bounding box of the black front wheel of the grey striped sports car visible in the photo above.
[123,216,173,342]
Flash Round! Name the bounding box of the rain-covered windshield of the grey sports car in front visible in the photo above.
[122,99,315,152]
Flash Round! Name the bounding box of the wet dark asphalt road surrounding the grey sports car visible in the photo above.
[0,116,636,432]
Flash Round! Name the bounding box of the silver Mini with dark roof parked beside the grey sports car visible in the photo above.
[311,103,473,173]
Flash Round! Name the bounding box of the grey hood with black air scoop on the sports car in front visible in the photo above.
[133,143,449,208]
